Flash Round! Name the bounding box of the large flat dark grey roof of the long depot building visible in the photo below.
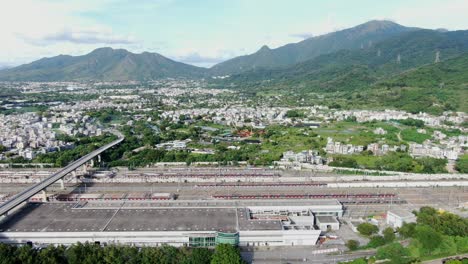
[0,203,237,232]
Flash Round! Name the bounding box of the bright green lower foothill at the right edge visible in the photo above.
[374,53,468,114]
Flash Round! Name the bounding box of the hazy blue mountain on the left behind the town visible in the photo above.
[0,48,206,81]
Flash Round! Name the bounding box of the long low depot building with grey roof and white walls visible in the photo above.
[0,200,343,247]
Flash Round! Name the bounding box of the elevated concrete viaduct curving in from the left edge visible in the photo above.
[0,134,124,216]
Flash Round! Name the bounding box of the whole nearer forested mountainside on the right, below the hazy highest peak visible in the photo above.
[217,30,468,114]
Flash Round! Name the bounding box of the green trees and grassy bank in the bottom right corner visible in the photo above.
[347,207,468,264]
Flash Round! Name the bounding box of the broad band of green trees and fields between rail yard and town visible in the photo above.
[4,114,458,172]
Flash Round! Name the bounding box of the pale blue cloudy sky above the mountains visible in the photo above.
[0,0,468,67]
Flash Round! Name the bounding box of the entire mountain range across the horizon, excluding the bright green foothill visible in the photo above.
[0,20,468,83]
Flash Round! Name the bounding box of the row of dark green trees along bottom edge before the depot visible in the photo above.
[0,243,244,264]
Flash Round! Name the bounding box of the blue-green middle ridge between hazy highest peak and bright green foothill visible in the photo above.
[223,30,468,91]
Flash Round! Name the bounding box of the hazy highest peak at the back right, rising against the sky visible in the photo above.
[210,20,417,75]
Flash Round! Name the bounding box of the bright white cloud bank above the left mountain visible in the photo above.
[0,0,135,65]
